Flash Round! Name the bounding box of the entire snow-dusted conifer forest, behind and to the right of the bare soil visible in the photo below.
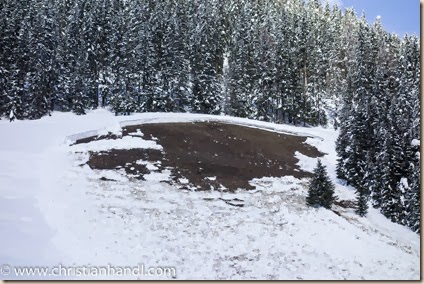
[0,0,420,231]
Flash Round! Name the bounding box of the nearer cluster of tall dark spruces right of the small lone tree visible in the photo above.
[336,20,420,232]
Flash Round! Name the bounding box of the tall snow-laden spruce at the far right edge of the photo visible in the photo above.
[381,36,419,224]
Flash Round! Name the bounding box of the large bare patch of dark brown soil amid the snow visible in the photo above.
[81,122,323,191]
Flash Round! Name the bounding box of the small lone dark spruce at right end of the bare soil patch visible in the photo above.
[306,160,336,209]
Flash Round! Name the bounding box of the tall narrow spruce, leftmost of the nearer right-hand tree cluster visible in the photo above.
[336,15,376,188]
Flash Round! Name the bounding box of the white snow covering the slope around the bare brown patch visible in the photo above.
[0,110,420,280]
